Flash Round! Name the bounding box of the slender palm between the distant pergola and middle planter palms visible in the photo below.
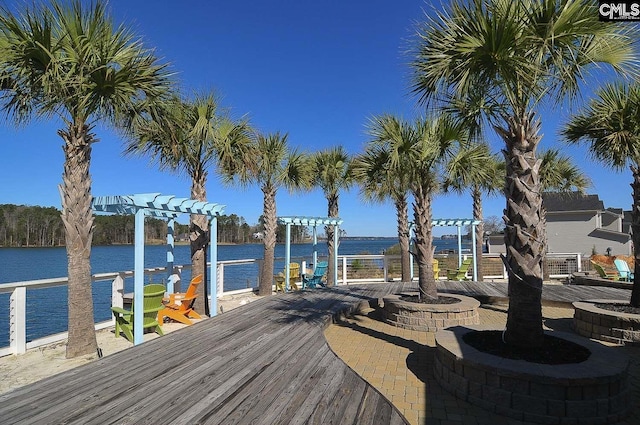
[312,146,354,286]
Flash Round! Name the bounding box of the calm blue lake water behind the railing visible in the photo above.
[0,239,464,347]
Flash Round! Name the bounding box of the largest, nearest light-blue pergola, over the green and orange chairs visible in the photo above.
[91,193,225,345]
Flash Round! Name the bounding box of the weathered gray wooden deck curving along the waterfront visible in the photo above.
[0,282,630,425]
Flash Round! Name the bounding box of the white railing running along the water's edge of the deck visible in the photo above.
[0,253,582,357]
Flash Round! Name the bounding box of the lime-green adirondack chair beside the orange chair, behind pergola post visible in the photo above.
[111,283,165,342]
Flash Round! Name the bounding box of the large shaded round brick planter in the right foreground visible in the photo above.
[434,326,630,424]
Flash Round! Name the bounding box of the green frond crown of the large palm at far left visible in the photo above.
[0,0,172,124]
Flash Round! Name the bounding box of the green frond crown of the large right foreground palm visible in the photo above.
[411,0,638,115]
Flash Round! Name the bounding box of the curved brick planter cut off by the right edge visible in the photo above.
[573,300,640,344]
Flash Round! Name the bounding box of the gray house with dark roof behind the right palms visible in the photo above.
[488,192,631,256]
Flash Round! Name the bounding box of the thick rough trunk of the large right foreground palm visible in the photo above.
[496,113,544,348]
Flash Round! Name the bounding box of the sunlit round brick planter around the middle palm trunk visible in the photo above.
[382,294,480,332]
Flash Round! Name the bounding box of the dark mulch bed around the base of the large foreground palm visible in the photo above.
[462,331,591,365]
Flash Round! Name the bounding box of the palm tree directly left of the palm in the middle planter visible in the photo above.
[353,143,411,282]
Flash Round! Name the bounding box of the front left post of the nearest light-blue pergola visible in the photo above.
[132,208,145,345]
